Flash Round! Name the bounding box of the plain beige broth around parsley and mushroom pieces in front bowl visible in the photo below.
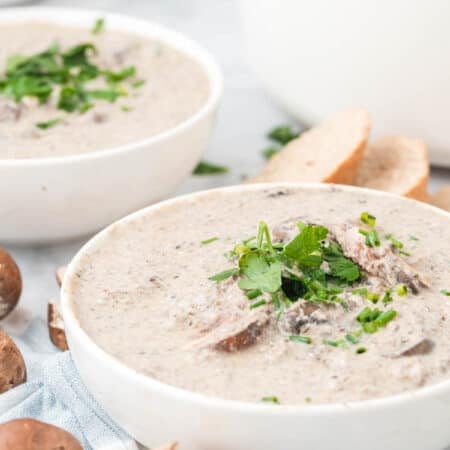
[67,187,450,404]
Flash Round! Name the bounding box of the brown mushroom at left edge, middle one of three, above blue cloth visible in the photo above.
[0,330,27,394]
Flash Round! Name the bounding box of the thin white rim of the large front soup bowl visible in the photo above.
[61,183,450,416]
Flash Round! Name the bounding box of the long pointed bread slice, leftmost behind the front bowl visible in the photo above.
[248,109,370,184]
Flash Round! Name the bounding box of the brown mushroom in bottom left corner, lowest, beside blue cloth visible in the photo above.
[0,419,83,450]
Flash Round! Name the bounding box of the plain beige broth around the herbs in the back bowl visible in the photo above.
[0,22,209,159]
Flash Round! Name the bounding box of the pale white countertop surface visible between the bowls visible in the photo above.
[0,0,450,446]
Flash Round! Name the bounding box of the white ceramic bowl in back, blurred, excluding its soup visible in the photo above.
[0,8,222,243]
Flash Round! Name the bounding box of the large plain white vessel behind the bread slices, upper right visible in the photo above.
[239,0,450,167]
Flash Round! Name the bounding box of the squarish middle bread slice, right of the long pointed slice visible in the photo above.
[355,136,430,200]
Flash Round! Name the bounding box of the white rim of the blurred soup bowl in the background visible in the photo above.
[0,6,223,168]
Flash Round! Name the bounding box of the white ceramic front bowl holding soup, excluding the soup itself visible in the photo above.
[62,184,450,450]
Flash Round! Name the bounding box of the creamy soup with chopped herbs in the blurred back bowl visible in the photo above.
[0,22,210,159]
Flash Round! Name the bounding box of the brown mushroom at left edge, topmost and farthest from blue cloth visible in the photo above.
[0,247,22,319]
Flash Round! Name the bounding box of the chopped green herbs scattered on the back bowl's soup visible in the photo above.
[0,19,142,129]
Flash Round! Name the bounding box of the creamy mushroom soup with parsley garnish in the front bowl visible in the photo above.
[65,185,450,404]
